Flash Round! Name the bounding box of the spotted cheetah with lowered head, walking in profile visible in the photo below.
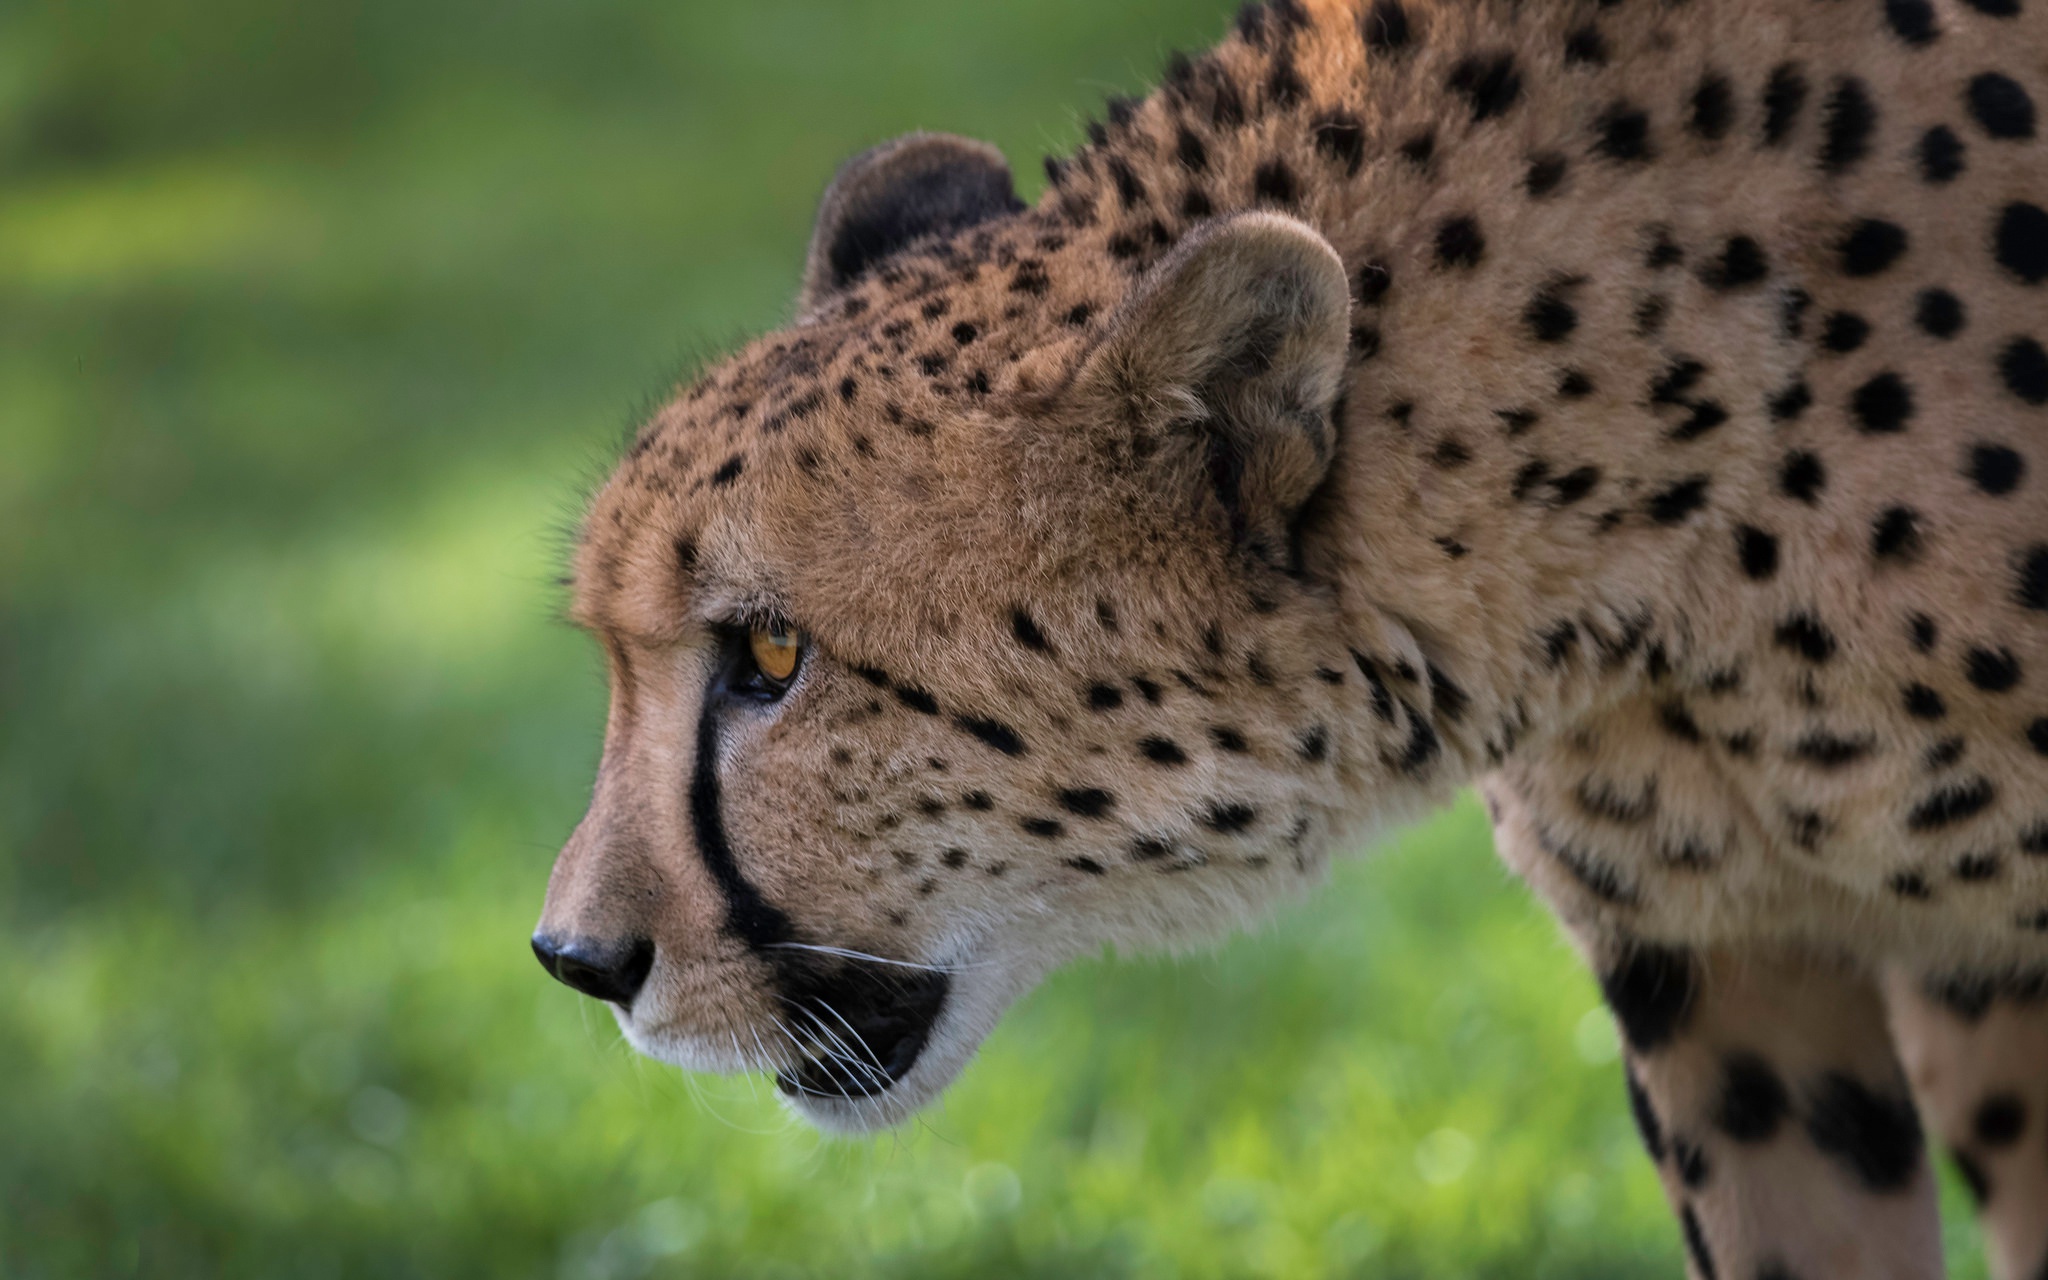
[532,0,2048,1280]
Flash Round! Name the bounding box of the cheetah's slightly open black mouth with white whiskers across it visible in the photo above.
[774,965,952,1102]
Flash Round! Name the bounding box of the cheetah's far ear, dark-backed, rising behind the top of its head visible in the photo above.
[797,133,1024,311]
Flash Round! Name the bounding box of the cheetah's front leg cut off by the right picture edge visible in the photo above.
[1886,973,2048,1280]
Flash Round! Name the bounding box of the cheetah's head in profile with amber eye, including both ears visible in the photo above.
[535,137,1364,1128]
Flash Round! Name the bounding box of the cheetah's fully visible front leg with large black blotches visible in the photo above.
[1587,936,1942,1280]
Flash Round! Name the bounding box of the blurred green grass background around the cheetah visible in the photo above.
[0,0,1982,1280]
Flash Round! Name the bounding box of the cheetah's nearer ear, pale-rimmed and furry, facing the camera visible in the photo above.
[1071,213,1352,559]
